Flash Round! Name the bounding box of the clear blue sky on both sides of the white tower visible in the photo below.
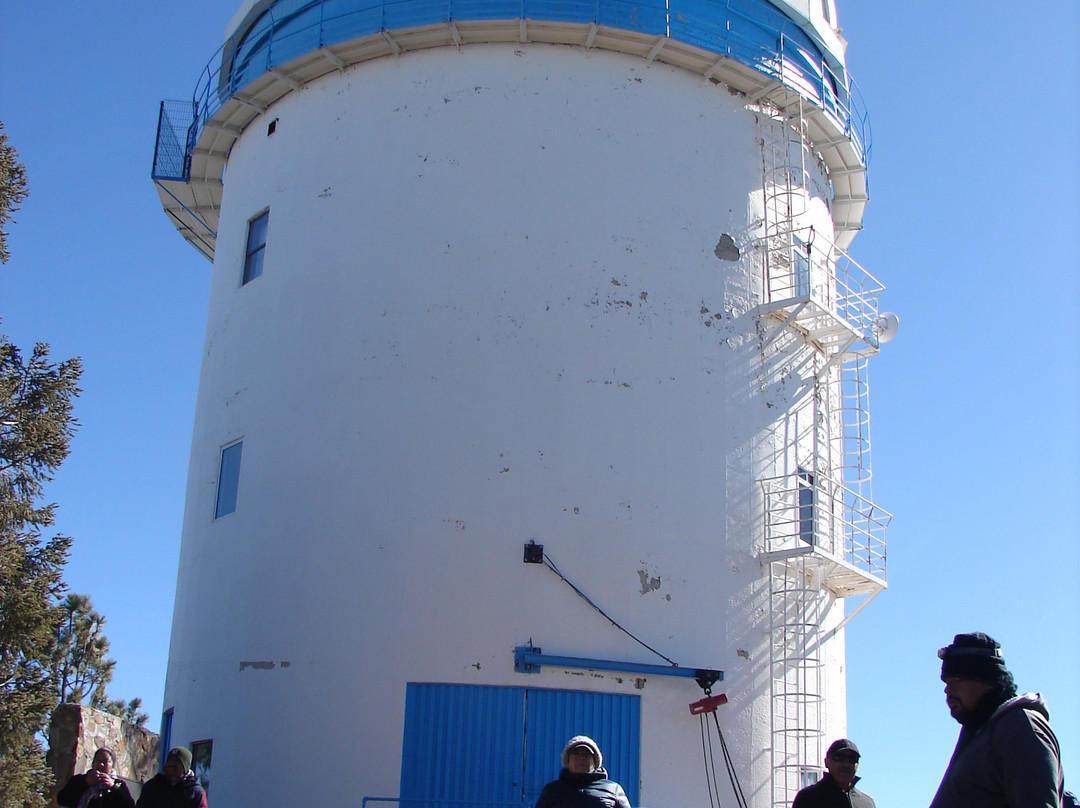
[0,0,1080,808]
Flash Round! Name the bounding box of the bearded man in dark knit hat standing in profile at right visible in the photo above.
[930,632,1065,808]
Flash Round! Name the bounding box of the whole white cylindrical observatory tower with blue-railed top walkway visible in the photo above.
[153,0,895,808]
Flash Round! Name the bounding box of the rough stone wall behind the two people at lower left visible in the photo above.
[46,704,161,803]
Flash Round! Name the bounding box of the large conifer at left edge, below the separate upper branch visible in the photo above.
[0,336,82,808]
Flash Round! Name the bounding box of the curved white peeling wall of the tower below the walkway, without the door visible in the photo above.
[157,1,885,808]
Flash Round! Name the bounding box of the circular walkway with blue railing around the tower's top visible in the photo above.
[151,0,870,259]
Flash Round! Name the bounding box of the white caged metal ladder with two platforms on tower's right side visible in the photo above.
[759,94,891,808]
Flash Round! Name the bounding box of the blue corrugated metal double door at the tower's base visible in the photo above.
[401,684,640,808]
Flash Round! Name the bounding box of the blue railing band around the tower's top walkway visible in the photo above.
[152,0,870,180]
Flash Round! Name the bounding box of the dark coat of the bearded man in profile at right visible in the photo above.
[930,693,1065,808]
